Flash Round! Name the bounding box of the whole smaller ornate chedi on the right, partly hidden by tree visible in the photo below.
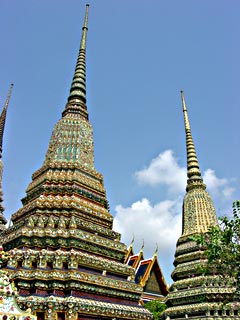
[164,92,240,320]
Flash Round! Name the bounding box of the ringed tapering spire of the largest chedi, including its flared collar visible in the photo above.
[63,4,89,118]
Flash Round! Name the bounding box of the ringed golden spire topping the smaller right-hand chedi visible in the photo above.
[181,91,206,191]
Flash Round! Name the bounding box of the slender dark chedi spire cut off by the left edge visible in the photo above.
[0,84,13,230]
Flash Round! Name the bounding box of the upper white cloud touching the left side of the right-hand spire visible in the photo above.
[135,150,187,194]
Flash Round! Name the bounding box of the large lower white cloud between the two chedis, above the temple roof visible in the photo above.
[114,198,181,282]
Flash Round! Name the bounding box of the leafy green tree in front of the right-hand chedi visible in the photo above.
[191,200,240,297]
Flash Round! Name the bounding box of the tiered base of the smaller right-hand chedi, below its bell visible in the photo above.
[165,236,240,320]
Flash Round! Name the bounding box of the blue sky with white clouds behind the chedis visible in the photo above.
[0,0,240,283]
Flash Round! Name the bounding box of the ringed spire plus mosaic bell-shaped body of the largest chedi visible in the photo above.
[42,5,95,170]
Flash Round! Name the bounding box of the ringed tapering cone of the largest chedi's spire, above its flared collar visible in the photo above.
[68,4,89,108]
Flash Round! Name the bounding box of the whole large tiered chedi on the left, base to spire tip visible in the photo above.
[1,5,152,320]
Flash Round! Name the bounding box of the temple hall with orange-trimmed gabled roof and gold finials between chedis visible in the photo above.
[125,244,169,303]
